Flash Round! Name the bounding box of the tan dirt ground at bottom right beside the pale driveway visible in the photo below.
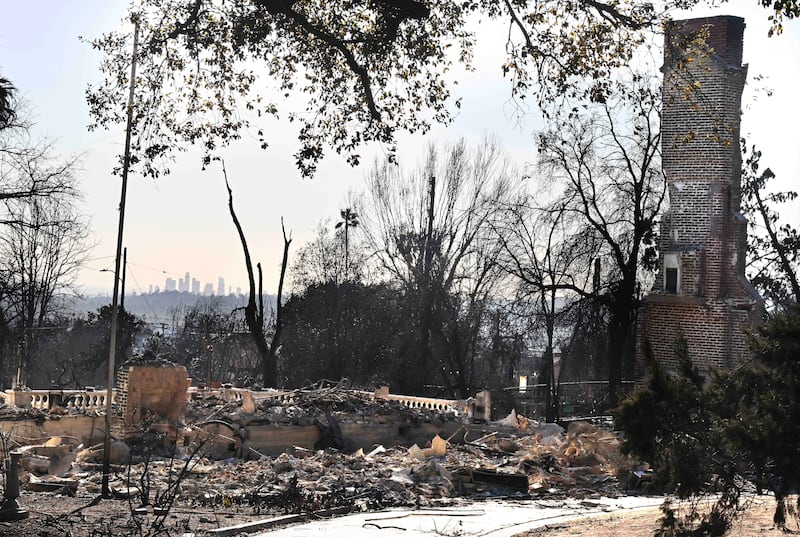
[516,498,800,537]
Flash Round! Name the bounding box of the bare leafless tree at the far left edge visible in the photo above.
[0,115,89,388]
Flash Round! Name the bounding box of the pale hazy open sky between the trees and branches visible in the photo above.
[0,0,800,294]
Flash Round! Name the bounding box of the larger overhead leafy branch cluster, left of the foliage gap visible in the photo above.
[87,0,471,179]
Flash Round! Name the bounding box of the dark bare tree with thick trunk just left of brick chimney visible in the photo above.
[539,74,666,406]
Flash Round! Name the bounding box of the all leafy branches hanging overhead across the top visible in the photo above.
[87,0,798,176]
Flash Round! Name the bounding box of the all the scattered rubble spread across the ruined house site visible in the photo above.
[6,402,633,514]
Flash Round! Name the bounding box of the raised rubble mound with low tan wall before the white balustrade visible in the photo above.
[186,388,465,459]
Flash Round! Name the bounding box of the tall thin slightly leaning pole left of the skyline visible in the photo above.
[102,21,139,498]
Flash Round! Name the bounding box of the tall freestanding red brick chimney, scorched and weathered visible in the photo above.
[637,16,761,372]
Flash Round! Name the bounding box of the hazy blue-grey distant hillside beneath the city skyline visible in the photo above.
[66,291,276,323]
